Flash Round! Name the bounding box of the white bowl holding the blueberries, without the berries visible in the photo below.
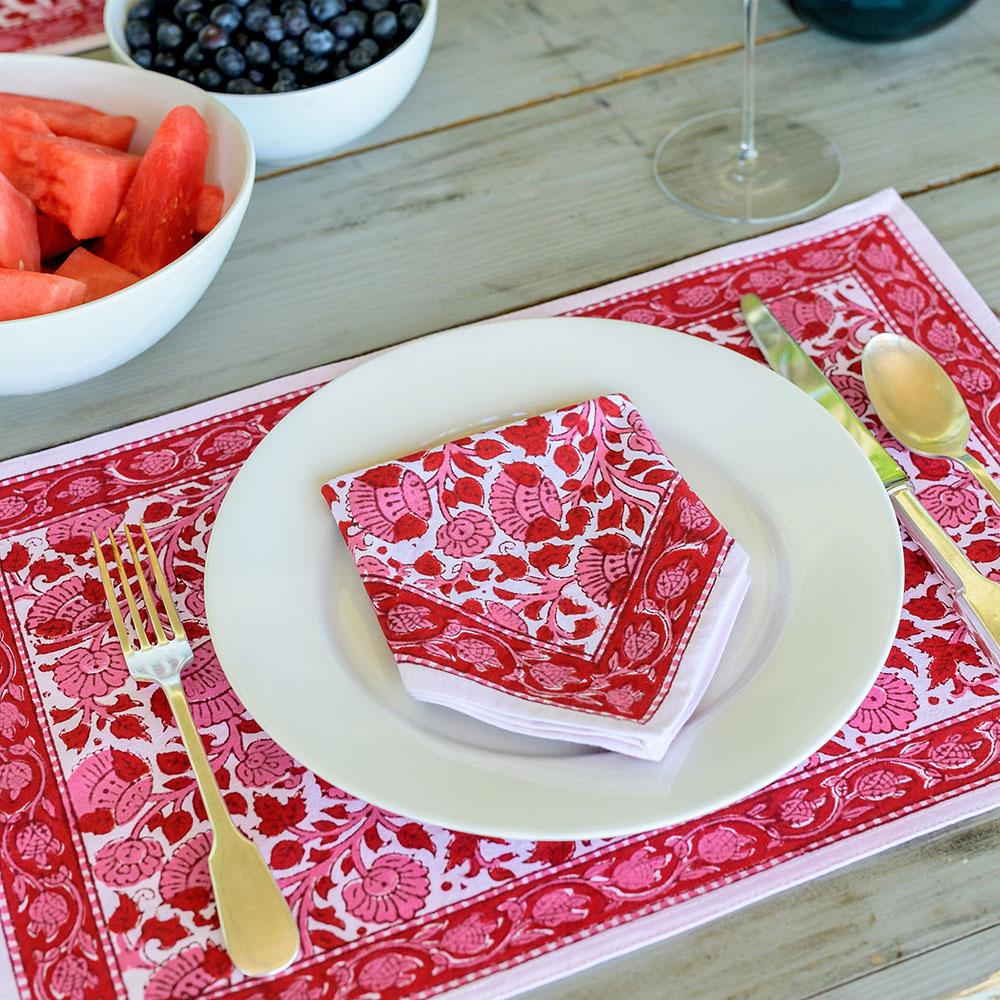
[104,0,438,166]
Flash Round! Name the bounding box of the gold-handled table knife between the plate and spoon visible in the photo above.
[740,295,1000,664]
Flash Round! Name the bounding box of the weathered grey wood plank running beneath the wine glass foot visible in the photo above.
[0,6,1000,455]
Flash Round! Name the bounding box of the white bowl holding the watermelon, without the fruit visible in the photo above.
[0,55,254,395]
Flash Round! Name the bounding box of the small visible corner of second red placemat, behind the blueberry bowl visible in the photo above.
[0,0,104,52]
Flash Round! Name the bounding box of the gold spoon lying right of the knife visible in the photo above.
[861,333,1000,507]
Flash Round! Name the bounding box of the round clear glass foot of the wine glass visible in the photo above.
[653,108,843,222]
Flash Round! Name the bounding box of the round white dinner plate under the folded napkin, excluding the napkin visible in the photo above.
[205,319,903,840]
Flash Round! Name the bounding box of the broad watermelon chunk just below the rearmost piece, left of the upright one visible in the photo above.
[0,118,139,240]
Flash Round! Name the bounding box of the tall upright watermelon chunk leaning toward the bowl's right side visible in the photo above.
[99,104,209,278]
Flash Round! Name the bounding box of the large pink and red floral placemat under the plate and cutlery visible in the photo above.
[0,192,1000,1000]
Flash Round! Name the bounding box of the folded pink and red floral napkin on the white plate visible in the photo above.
[323,395,750,760]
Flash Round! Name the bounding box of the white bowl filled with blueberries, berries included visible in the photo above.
[104,0,438,166]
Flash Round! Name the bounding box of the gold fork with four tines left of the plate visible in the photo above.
[91,523,299,976]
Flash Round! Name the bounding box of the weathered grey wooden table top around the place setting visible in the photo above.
[7,0,1000,1000]
